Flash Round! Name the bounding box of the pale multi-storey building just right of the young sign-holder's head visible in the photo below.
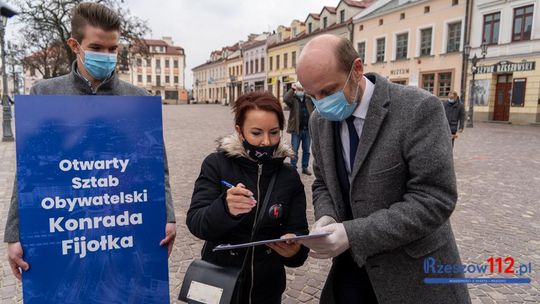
[118,37,188,104]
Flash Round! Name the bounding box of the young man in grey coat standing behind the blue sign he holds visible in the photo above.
[4,3,176,279]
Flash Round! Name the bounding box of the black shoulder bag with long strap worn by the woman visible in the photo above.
[178,170,279,304]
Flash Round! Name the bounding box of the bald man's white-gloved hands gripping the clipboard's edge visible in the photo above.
[301,217,350,259]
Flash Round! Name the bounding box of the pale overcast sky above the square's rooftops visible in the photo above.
[124,0,332,89]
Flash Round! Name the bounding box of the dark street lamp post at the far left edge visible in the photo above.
[0,2,17,142]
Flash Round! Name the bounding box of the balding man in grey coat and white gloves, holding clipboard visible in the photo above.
[297,35,470,304]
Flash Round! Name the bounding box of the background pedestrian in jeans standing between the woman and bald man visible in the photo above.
[283,82,315,175]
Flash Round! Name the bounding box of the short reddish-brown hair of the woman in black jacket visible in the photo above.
[233,92,285,130]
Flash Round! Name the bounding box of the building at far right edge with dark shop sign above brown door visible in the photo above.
[465,0,540,124]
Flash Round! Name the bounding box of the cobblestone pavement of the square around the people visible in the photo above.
[0,105,540,304]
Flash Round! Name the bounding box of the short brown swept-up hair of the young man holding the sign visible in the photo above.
[71,2,121,43]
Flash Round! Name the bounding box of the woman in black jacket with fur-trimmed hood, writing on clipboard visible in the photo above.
[186,92,309,304]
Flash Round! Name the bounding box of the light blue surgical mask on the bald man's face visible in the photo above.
[313,63,360,121]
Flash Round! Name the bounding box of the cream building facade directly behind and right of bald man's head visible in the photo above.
[353,0,466,99]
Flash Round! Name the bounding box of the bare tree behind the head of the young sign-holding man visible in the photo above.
[17,0,150,78]
